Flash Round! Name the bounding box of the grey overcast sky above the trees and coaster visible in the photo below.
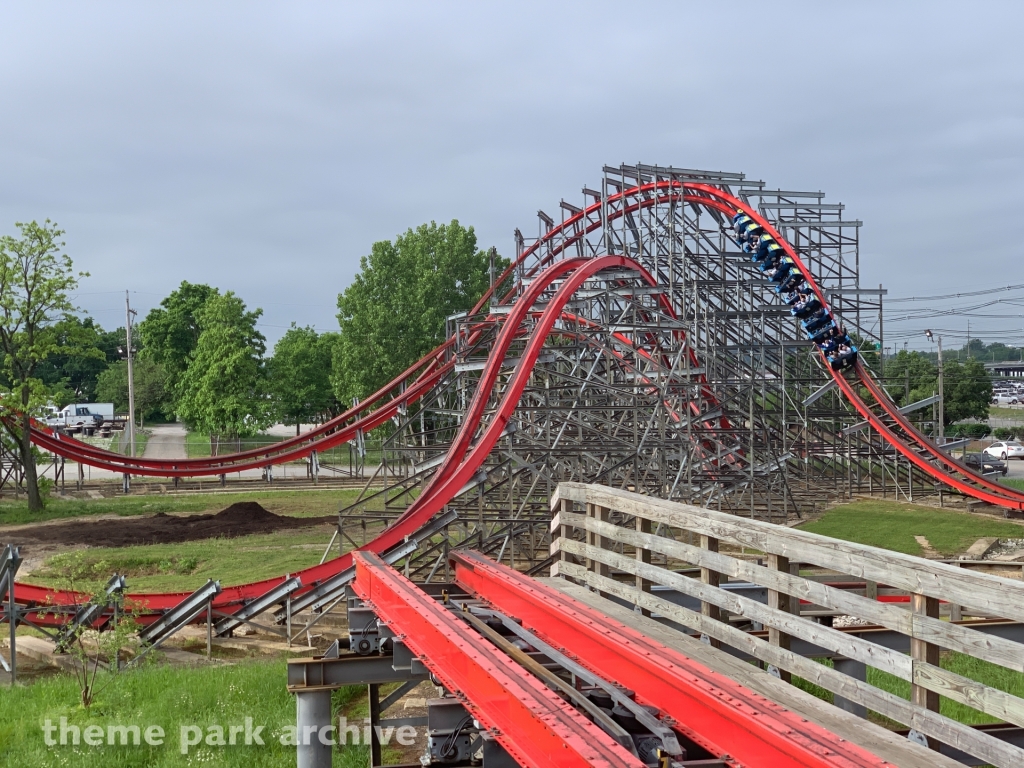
[0,0,1024,352]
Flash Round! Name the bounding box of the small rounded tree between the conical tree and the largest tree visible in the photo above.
[267,323,340,434]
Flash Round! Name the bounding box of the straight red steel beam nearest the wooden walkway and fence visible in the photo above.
[451,550,889,768]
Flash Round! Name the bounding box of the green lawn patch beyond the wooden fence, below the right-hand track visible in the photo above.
[801,501,1024,555]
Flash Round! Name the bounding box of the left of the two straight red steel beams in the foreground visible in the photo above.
[354,552,644,768]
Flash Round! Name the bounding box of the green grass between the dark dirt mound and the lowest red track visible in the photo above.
[24,526,338,592]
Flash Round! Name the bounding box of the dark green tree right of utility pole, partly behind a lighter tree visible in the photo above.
[138,281,219,391]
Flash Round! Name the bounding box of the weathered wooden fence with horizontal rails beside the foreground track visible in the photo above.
[552,483,1024,768]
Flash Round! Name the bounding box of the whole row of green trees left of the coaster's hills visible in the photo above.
[0,220,497,509]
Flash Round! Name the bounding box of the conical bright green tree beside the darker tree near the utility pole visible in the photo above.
[175,291,270,455]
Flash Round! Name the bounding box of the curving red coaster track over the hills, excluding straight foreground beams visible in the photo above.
[8,181,1024,623]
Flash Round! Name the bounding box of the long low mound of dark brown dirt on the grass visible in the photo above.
[6,502,337,549]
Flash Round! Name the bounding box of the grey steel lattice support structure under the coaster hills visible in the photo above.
[341,165,938,579]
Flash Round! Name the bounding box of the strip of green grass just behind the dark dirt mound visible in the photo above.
[0,488,374,525]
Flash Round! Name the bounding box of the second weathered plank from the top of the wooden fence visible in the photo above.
[565,513,1024,672]
